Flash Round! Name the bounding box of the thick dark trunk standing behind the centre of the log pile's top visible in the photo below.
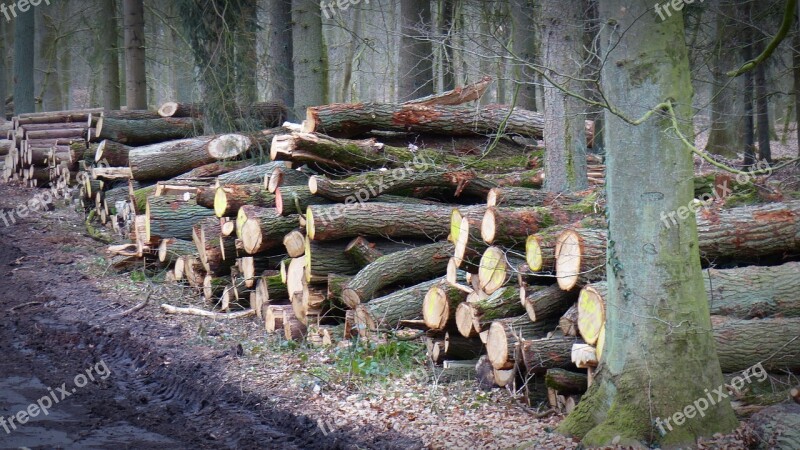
[397,0,433,101]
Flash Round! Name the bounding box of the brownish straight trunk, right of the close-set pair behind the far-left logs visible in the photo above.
[122,0,147,109]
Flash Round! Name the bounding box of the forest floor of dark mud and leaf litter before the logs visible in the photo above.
[0,180,772,449]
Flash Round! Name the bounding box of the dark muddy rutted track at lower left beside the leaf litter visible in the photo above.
[0,186,422,449]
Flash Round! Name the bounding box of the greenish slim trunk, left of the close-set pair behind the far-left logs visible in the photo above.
[95,0,122,110]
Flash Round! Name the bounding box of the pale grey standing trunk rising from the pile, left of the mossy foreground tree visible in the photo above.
[539,0,589,192]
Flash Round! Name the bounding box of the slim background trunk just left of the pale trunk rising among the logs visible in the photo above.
[511,0,537,111]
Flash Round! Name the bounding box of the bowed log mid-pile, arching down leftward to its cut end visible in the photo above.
[342,242,453,313]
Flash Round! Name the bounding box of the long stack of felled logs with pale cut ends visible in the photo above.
[0,79,800,410]
